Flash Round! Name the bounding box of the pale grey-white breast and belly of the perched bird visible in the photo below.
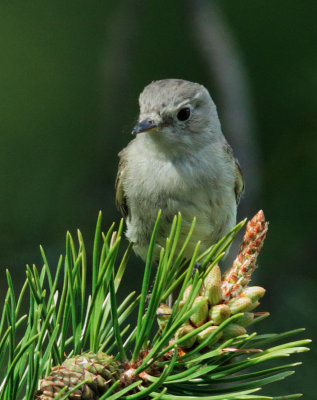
[124,143,236,259]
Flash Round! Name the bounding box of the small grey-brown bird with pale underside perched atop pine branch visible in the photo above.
[115,79,244,260]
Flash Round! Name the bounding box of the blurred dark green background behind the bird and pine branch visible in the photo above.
[0,0,317,399]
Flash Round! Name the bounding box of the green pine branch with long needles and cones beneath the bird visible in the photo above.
[0,211,310,400]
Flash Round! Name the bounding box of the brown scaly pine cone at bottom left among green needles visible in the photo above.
[35,353,119,400]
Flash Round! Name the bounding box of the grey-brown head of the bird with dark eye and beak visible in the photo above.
[132,79,222,152]
